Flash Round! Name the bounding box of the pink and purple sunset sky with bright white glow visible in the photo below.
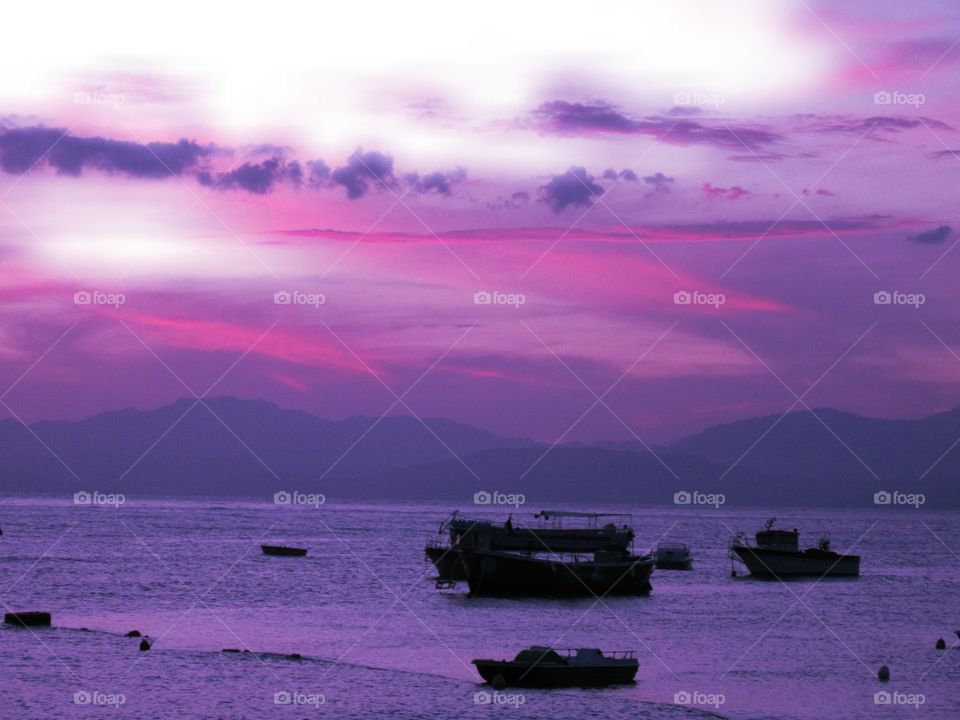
[0,0,960,442]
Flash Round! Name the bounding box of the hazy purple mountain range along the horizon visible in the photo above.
[0,397,960,508]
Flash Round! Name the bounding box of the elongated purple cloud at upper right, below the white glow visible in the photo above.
[533,100,783,150]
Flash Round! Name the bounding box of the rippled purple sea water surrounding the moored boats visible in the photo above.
[0,499,960,720]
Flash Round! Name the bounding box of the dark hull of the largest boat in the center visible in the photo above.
[460,549,653,597]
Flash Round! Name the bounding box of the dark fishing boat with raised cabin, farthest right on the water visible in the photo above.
[730,518,860,578]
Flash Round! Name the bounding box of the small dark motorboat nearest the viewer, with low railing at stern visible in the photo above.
[473,646,639,687]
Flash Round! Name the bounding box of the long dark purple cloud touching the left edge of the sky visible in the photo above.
[0,127,217,179]
